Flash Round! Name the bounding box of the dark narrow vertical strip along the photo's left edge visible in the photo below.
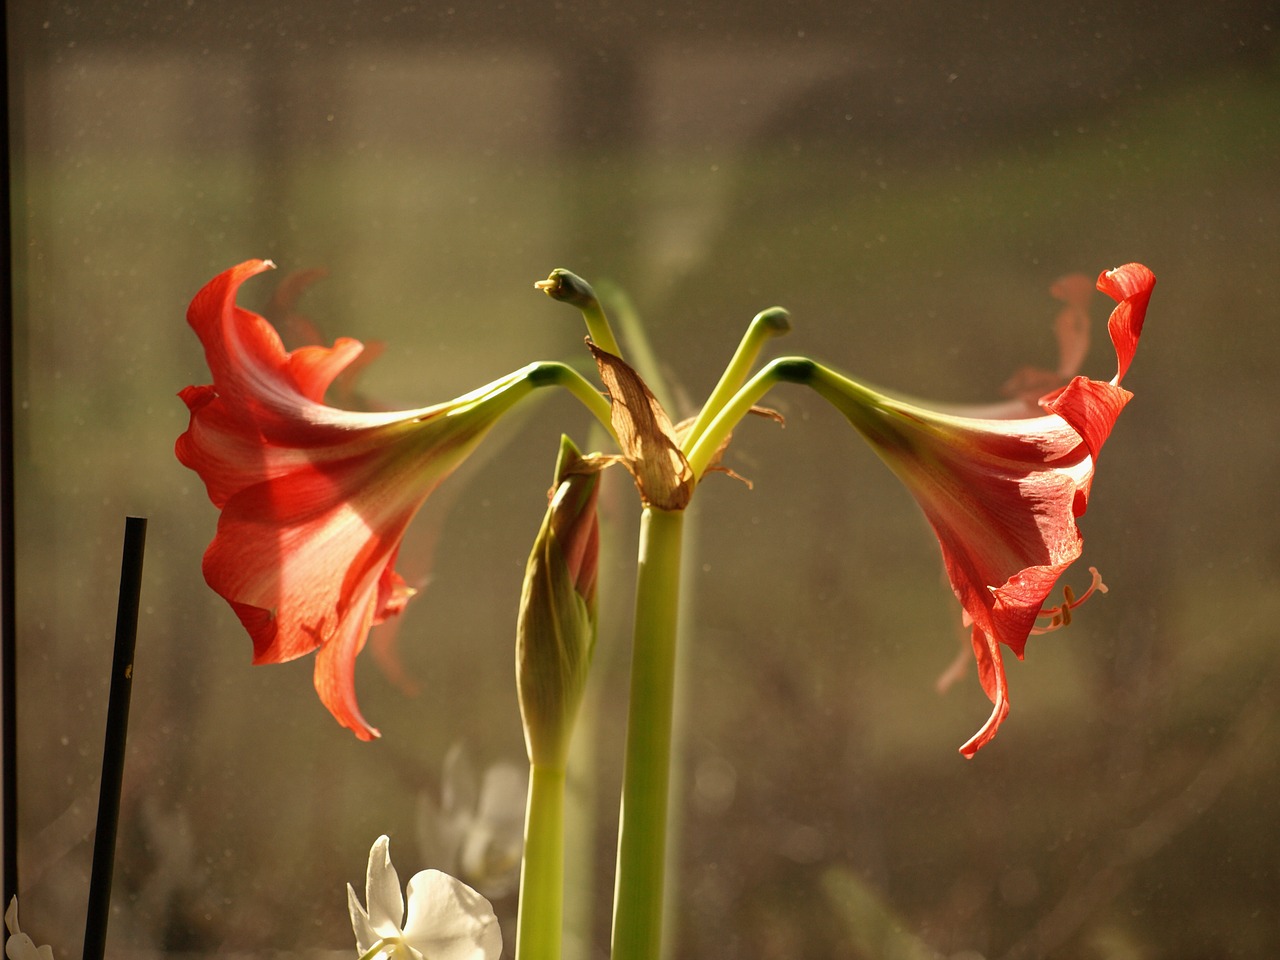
[0,3,18,909]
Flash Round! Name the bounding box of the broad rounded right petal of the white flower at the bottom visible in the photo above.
[404,870,502,960]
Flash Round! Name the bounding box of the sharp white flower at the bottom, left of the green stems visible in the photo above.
[348,836,502,960]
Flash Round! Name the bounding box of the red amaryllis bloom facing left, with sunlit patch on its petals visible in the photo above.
[177,260,540,740]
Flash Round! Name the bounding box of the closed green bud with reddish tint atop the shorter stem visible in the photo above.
[516,436,600,769]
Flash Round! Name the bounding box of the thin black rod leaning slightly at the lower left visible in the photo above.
[83,517,147,960]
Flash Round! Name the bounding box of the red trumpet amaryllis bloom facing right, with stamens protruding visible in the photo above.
[809,264,1156,756]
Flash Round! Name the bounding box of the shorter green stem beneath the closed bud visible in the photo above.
[516,763,564,960]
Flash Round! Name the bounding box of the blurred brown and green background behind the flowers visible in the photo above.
[8,0,1280,960]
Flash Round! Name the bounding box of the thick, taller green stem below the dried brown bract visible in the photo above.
[613,507,684,960]
